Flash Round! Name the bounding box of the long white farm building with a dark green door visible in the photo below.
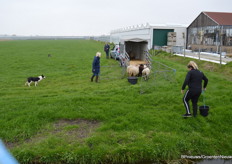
[110,23,186,49]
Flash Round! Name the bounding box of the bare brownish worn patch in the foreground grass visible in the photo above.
[6,119,100,149]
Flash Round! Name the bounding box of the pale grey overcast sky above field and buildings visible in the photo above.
[0,0,232,36]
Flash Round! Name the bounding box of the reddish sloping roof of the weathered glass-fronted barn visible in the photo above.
[203,12,232,25]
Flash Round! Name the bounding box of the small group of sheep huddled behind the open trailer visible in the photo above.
[127,64,151,80]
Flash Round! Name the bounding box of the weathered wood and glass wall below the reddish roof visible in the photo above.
[186,13,232,53]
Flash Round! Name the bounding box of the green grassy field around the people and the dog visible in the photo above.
[0,40,232,163]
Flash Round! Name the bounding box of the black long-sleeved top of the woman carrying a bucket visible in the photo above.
[182,69,208,90]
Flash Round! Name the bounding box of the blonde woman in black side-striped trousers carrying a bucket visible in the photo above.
[181,61,208,117]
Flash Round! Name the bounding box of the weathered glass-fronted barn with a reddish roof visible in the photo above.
[186,12,232,54]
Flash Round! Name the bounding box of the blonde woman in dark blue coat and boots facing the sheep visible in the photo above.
[91,52,101,82]
